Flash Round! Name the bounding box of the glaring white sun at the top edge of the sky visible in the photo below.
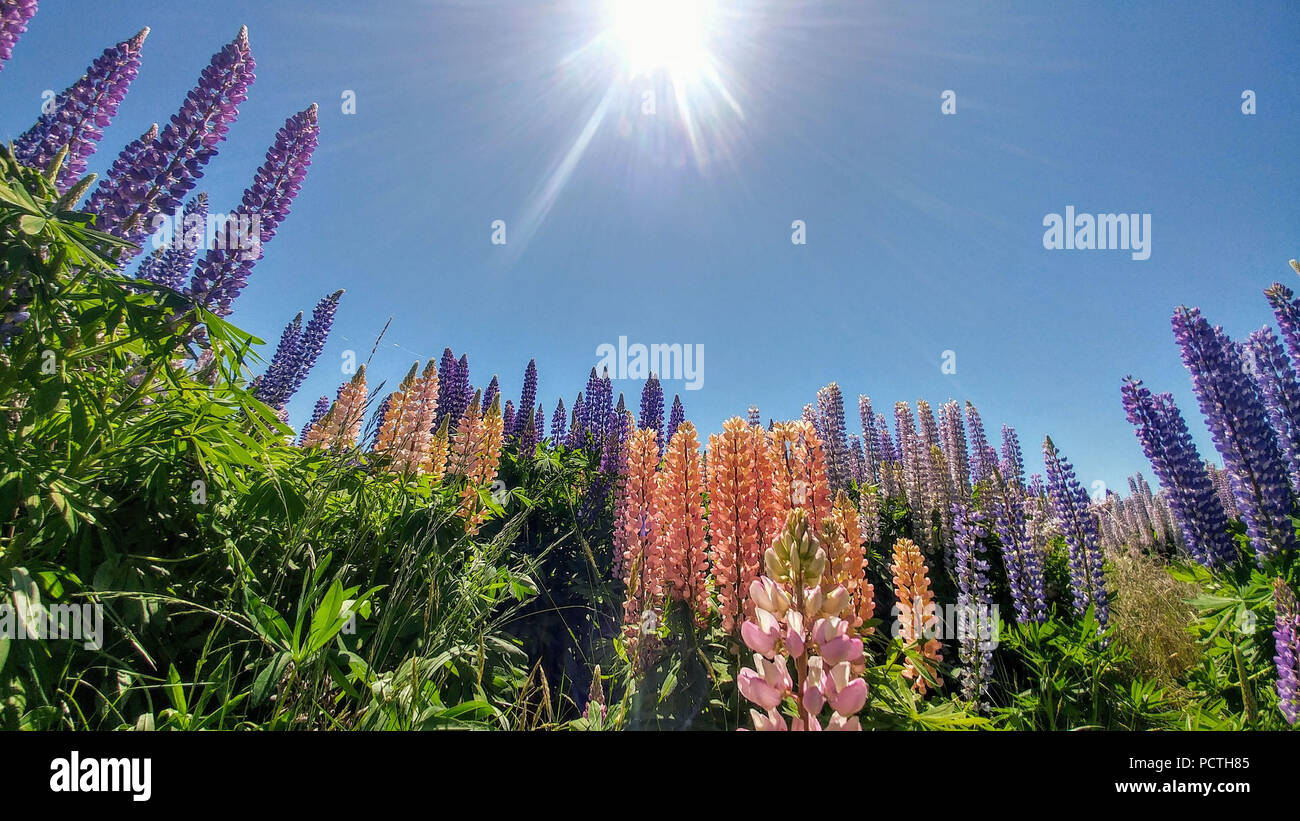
[608,0,712,81]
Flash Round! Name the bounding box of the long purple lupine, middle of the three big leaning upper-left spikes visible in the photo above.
[86,29,256,264]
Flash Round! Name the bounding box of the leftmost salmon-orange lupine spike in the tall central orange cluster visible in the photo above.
[614,427,663,656]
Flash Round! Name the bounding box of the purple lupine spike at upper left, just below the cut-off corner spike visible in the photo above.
[13,27,150,194]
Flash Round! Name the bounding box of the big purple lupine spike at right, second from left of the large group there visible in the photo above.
[1171,308,1296,562]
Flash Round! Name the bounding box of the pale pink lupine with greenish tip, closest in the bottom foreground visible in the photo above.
[736,511,867,730]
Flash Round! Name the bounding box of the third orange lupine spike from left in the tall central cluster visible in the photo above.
[709,417,766,633]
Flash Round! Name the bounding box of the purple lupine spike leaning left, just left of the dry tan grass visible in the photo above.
[1043,436,1110,629]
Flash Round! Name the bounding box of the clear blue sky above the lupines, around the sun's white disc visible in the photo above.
[0,0,1300,487]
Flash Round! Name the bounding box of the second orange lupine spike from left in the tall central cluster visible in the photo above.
[655,422,709,626]
